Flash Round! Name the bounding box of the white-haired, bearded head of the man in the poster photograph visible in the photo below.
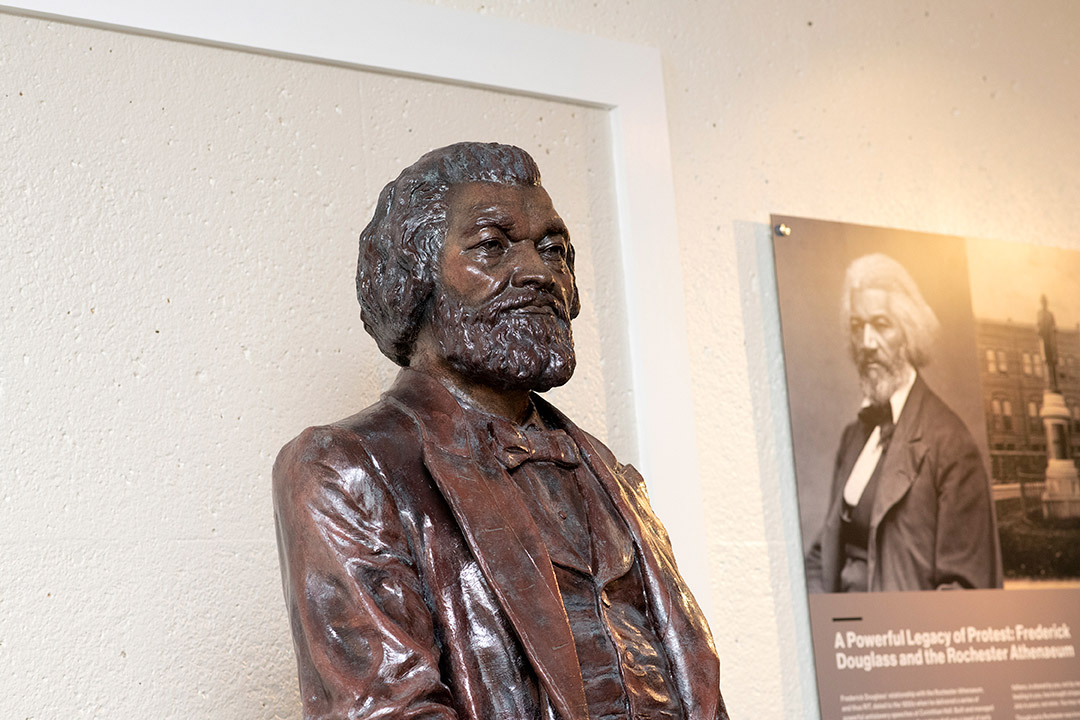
[840,253,939,403]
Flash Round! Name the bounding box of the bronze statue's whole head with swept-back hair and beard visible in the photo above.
[356,142,580,390]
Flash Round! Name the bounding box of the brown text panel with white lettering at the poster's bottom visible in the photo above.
[810,589,1080,720]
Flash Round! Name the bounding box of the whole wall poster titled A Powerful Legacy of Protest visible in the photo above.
[772,216,1080,720]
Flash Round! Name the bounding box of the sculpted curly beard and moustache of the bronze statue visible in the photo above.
[432,288,577,392]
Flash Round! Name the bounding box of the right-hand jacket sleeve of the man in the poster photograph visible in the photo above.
[934,430,1002,589]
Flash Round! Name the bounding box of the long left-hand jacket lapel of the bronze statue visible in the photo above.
[387,369,588,720]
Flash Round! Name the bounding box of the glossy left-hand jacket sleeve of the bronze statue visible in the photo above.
[273,427,457,720]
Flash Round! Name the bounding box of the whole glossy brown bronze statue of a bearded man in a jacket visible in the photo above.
[274,142,727,720]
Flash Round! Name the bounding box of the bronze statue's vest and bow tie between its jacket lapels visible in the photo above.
[479,411,684,720]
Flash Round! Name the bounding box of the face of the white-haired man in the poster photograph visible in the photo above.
[849,287,908,403]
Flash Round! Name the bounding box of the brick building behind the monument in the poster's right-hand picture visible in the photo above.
[975,320,1080,484]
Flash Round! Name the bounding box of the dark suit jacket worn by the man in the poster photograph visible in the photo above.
[806,377,1002,593]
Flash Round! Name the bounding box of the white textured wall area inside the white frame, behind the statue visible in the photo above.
[0,14,634,720]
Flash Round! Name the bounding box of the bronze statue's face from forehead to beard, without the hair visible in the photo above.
[431,182,575,391]
